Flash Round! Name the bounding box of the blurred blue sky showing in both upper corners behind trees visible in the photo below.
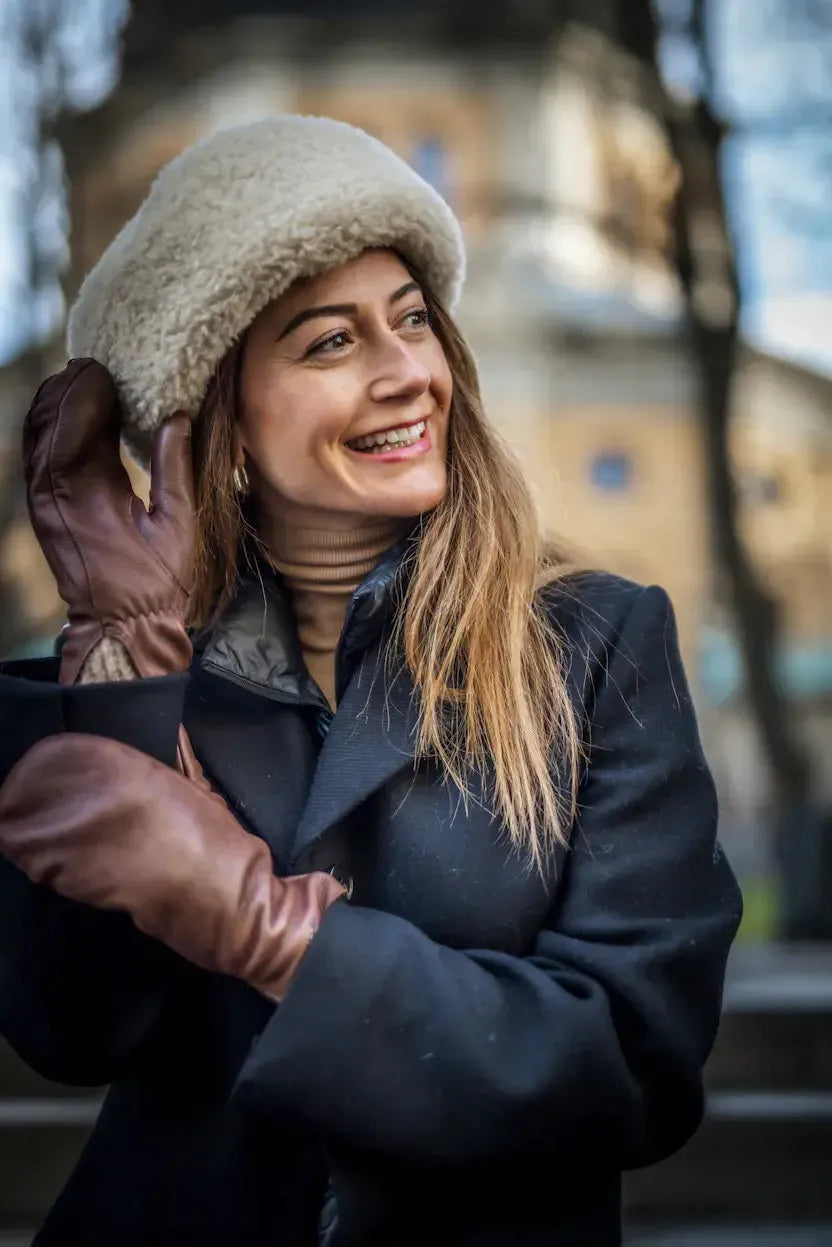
[0,0,832,374]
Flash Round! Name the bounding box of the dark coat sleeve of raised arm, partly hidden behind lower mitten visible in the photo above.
[0,660,187,1085]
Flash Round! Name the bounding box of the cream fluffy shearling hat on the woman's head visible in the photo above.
[67,115,465,464]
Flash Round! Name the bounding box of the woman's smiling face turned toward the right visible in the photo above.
[238,251,453,526]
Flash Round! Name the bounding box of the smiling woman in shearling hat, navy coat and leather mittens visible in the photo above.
[0,117,740,1247]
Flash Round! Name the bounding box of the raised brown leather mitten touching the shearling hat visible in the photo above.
[24,359,195,685]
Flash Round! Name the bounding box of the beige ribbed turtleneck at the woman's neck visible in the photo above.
[268,518,413,710]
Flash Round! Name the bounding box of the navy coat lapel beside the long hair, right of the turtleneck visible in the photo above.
[292,640,418,867]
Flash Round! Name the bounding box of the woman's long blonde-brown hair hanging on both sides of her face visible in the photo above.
[191,264,583,872]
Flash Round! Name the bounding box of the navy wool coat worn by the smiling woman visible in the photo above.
[0,544,741,1247]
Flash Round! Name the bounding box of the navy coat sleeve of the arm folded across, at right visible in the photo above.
[235,587,741,1168]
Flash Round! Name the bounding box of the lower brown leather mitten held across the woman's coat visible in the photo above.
[0,732,344,1000]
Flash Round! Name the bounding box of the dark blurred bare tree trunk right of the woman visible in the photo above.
[608,0,832,939]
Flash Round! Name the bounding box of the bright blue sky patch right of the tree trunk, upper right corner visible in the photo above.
[710,0,832,374]
